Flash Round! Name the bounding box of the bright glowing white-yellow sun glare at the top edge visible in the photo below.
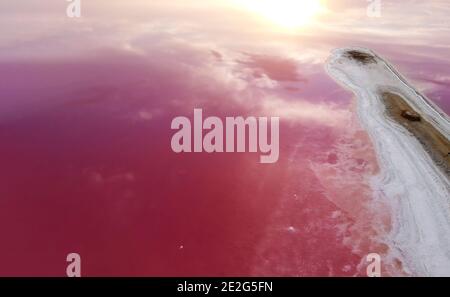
[234,0,325,28]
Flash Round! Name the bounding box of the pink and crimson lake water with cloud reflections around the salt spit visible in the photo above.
[0,1,450,276]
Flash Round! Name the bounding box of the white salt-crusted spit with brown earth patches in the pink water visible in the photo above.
[326,48,450,276]
